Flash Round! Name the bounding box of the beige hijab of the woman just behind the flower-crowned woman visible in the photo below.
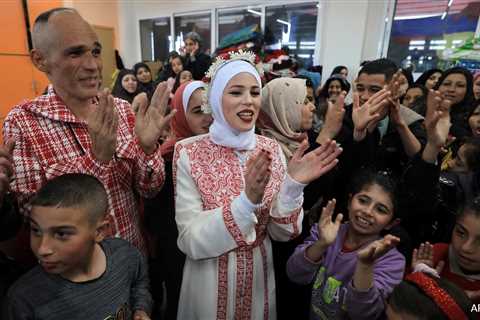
[259,78,307,161]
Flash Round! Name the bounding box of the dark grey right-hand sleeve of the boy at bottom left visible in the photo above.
[130,246,153,315]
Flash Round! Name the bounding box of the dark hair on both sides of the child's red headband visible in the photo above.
[388,278,475,320]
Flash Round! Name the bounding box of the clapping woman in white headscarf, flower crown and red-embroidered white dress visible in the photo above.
[173,53,341,319]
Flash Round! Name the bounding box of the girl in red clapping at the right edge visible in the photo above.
[412,197,480,303]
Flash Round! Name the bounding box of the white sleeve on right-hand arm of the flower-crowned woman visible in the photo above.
[267,146,306,241]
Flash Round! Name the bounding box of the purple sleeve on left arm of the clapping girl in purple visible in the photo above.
[287,224,323,284]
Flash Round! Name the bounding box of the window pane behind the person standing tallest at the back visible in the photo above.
[174,13,211,54]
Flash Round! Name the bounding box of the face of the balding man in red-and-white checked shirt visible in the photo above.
[32,12,102,101]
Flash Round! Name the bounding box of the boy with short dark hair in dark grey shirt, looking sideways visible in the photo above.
[2,174,152,320]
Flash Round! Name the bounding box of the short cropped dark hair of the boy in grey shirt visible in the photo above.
[31,173,108,224]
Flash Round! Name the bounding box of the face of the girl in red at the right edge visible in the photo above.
[452,212,480,273]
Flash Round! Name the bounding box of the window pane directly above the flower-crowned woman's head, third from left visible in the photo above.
[217,7,262,47]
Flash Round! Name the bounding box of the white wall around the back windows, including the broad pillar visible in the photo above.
[118,0,388,75]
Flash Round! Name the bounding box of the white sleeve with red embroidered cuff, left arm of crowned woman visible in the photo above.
[173,144,257,260]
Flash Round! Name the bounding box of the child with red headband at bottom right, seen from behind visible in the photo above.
[387,272,475,320]
